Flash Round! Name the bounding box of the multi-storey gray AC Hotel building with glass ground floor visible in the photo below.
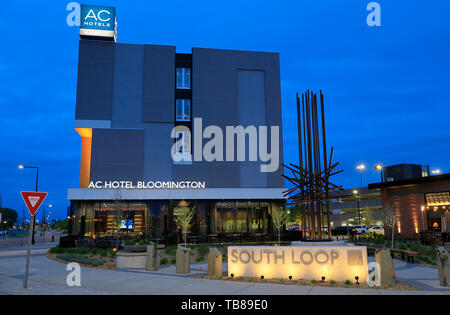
[68,36,285,240]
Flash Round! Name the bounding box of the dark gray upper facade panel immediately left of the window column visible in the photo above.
[142,45,175,123]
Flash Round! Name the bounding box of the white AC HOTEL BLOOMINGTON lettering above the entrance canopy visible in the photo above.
[88,180,206,189]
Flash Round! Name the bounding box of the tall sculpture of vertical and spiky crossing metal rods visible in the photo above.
[283,90,343,241]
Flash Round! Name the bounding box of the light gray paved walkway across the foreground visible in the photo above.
[0,244,450,295]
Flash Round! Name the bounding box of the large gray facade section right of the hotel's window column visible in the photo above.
[192,48,284,187]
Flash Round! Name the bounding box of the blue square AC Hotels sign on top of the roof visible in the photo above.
[80,4,117,41]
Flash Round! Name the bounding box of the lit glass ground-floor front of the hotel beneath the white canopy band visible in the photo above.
[70,200,281,240]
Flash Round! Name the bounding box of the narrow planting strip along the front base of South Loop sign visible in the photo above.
[199,275,419,291]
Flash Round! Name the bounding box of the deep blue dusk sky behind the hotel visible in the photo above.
[0,0,450,221]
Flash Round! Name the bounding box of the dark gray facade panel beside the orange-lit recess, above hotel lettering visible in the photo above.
[90,129,144,181]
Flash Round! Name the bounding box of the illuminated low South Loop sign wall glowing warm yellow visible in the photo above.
[228,245,368,281]
